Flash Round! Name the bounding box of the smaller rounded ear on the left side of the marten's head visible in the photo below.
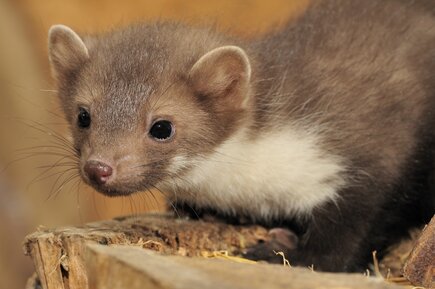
[48,25,89,78]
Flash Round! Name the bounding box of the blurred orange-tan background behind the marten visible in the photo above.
[0,0,307,289]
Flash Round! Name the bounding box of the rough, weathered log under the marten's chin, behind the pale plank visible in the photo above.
[24,215,267,289]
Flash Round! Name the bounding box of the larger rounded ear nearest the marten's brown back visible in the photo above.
[189,46,251,108]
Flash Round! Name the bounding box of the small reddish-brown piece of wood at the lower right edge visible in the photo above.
[403,216,435,288]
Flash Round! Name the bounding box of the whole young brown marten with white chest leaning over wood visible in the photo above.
[49,0,435,271]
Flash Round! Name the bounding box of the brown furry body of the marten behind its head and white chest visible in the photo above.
[247,0,435,264]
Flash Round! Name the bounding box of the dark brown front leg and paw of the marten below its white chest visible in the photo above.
[245,192,377,272]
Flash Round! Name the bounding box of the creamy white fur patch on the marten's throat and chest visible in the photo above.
[167,129,345,219]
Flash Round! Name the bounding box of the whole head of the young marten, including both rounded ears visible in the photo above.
[49,25,250,196]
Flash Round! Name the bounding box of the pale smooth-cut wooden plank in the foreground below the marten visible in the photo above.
[86,244,403,289]
